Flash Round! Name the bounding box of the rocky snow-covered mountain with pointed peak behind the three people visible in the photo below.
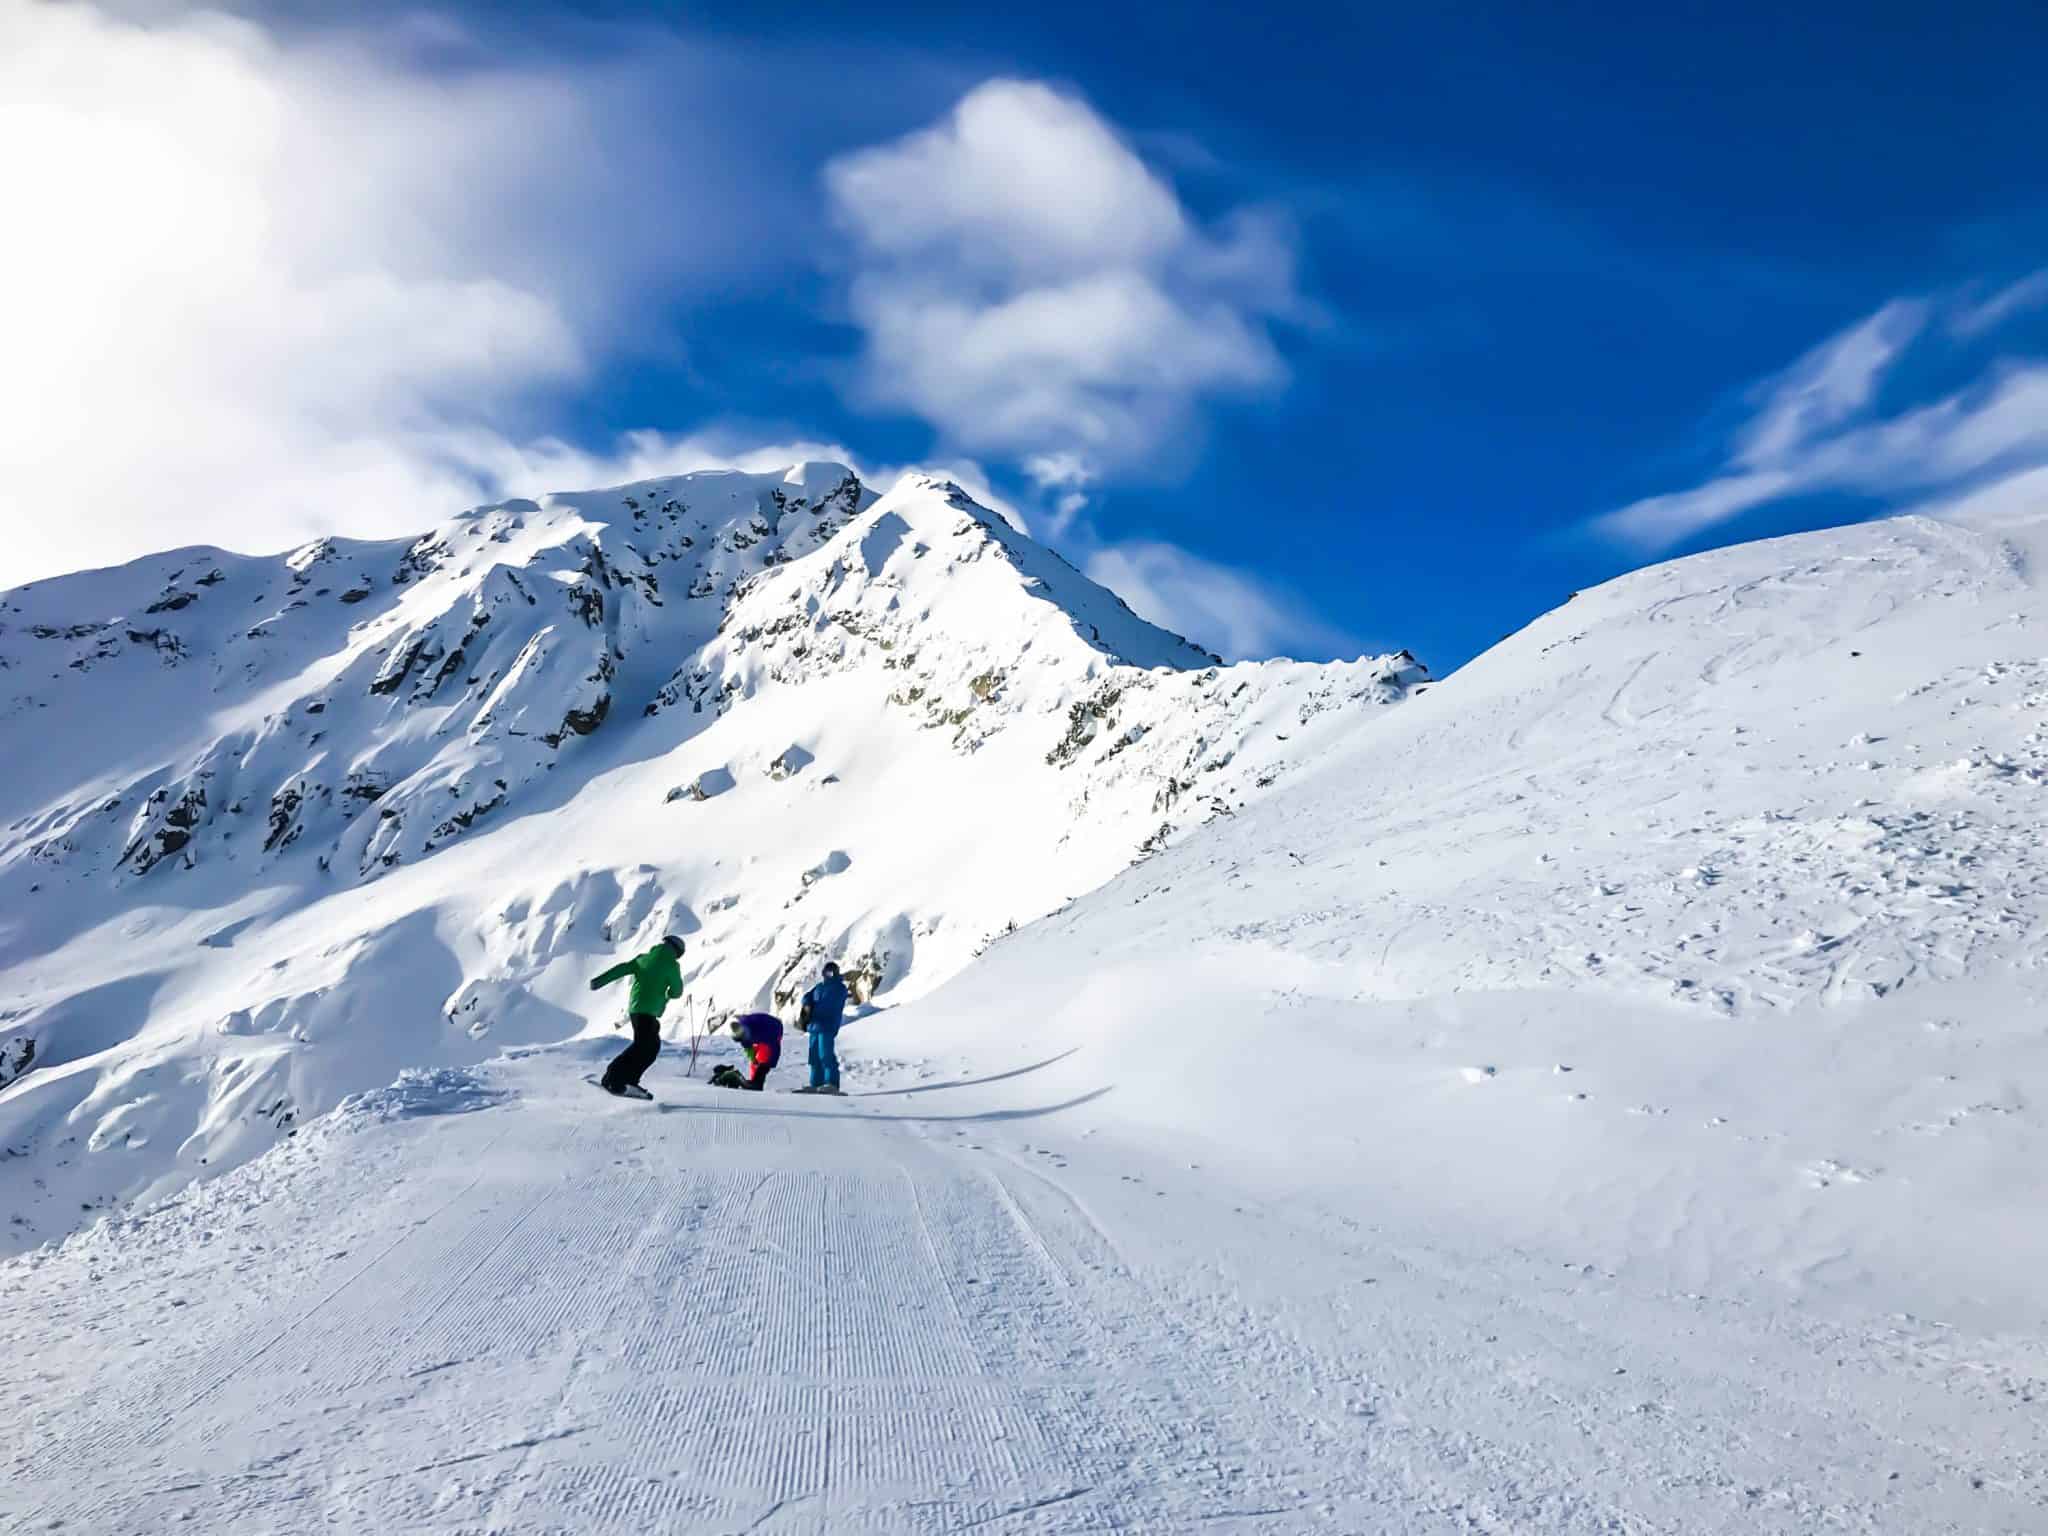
[0,465,1425,1247]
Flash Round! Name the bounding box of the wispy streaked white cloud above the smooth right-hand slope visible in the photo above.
[1589,279,2048,553]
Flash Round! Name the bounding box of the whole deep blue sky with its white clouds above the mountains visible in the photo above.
[0,0,2048,670]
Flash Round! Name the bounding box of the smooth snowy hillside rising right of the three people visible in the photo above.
[866,518,2048,1333]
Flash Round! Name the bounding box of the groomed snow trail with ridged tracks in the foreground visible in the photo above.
[0,1040,2042,1534]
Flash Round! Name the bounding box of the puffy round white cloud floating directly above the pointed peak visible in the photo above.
[825,80,1296,496]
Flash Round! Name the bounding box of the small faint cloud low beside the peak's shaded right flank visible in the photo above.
[1085,541,1362,662]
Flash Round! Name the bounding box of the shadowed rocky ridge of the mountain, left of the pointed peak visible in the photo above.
[0,465,872,874]
